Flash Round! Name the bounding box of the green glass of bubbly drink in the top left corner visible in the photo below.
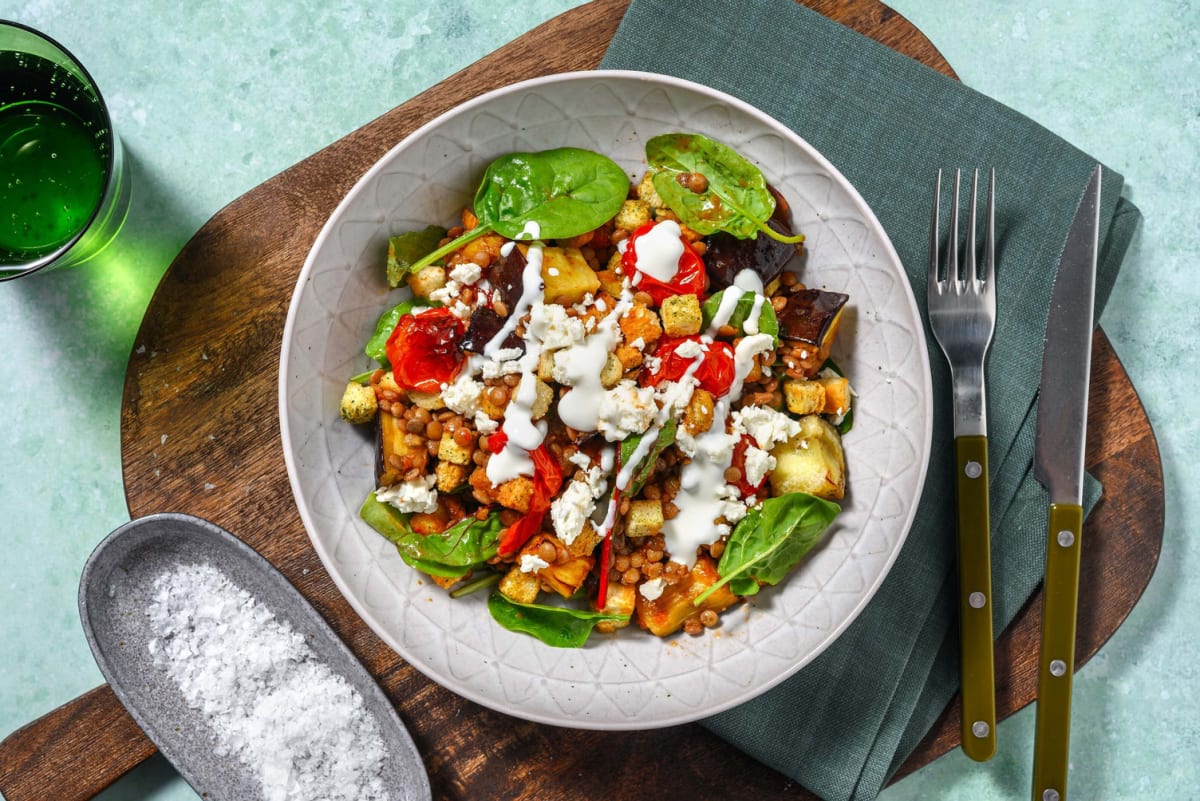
[0,19,130,281]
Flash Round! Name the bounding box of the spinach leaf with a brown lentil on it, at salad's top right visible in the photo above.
[646,133,804,243]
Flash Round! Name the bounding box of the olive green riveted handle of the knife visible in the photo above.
[1033,504,1084,801]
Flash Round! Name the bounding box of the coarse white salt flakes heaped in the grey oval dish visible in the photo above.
[146,565,389,801]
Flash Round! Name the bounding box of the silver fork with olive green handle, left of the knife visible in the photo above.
[928,169,996,761]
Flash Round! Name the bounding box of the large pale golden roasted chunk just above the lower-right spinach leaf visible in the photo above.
[770,415,846,500]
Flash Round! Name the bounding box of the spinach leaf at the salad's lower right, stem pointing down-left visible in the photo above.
[694,493,841,606]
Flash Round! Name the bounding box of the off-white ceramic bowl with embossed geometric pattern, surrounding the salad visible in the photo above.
[280,72,931,729]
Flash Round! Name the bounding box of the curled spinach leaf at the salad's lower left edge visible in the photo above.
[359,493,504,578]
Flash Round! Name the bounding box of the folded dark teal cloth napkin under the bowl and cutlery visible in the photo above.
[601,0,1140,801]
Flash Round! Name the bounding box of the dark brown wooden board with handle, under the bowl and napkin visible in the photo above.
[0,0,1163,801]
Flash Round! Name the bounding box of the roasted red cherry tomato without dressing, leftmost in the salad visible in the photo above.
[386,308,467,392]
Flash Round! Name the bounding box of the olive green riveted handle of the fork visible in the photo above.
[954,435,996,761]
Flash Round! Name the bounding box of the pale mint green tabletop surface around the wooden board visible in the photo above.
[0,0,1200,801]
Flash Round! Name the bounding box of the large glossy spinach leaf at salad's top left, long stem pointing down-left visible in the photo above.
[410,147,629,272]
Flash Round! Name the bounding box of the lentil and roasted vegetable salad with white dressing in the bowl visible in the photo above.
[341,133,853,646]
